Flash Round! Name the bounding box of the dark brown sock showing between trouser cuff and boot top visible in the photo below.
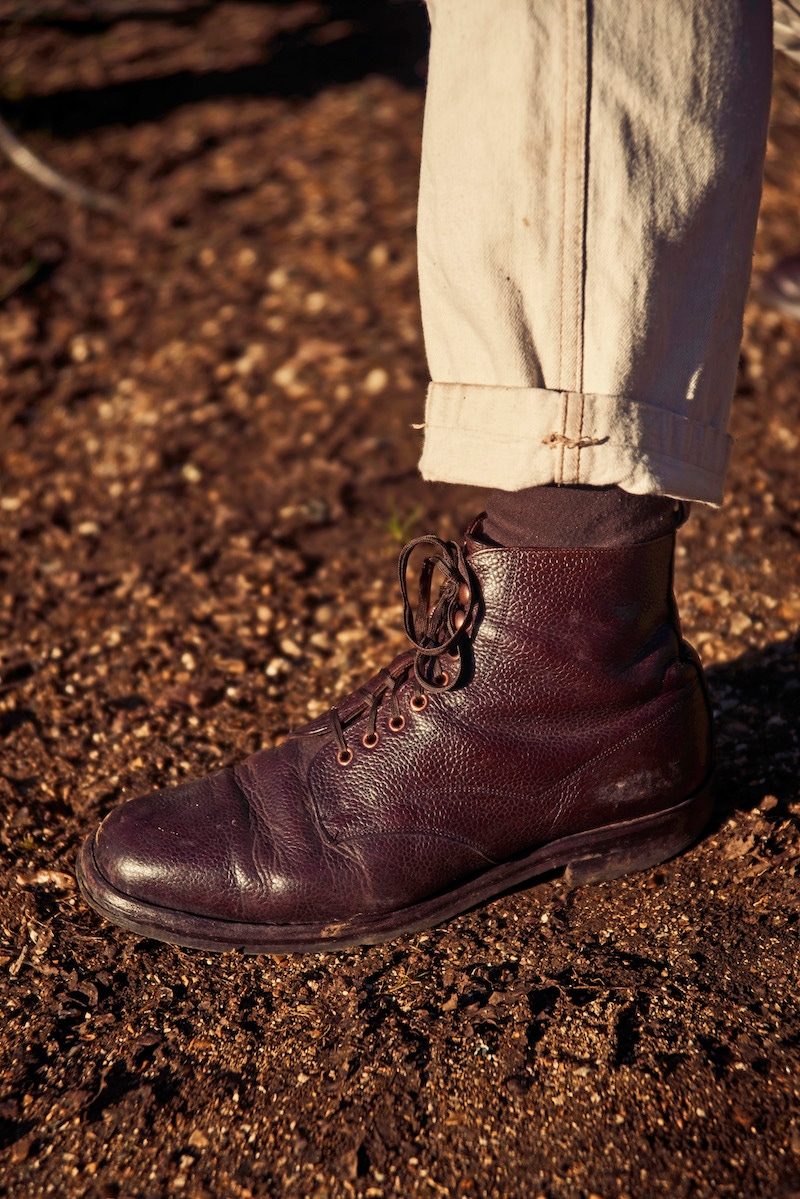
[482,484,688,549]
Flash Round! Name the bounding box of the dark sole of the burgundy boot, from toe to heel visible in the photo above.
[76,781,712,953]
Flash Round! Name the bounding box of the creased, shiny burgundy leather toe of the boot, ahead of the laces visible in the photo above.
[86,752,353,926]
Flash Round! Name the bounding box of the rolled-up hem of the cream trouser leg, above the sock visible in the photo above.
[420,382,733,505]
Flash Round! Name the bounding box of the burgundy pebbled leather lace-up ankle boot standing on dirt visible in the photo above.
[78,531,711,953]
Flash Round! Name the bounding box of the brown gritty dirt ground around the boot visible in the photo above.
[0,0,800,1199]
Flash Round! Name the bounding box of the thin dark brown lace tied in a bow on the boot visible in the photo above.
[307,536,474,766]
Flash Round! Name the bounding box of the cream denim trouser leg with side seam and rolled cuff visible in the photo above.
[419,0,777,504]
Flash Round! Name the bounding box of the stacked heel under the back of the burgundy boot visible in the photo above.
[564,783,712,887]
